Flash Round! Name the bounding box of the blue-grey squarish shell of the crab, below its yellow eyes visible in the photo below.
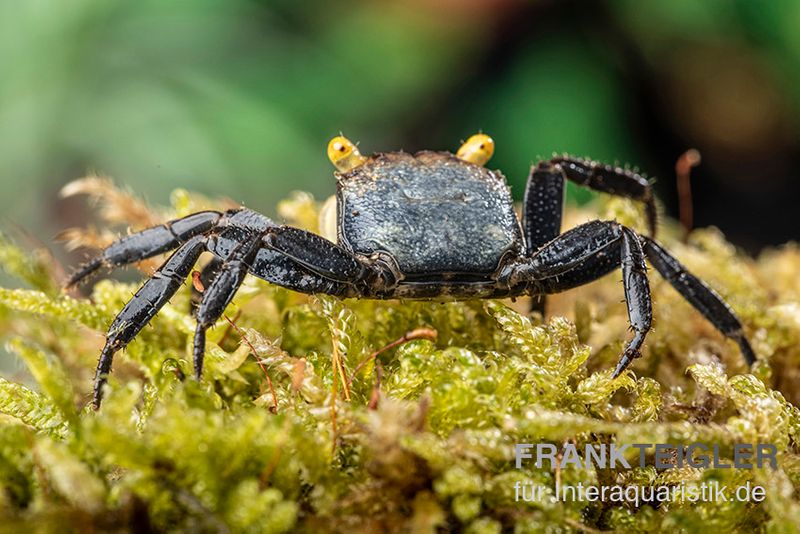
[336,151,524,279]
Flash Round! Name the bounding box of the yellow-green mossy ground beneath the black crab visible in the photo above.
[0,180,800,532]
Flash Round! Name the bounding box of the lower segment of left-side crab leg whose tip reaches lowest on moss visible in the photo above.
[93,236,206,409]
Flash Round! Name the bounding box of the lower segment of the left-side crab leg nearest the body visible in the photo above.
[193,234,261,380]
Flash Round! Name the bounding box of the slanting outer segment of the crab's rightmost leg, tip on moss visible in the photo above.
[643,238,756,365]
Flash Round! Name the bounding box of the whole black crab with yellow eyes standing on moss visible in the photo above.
[67,133,755,408]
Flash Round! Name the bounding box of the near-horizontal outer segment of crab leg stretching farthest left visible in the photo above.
[67,211,223,287]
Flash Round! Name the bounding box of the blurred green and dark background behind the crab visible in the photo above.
[0,0,800,253]
